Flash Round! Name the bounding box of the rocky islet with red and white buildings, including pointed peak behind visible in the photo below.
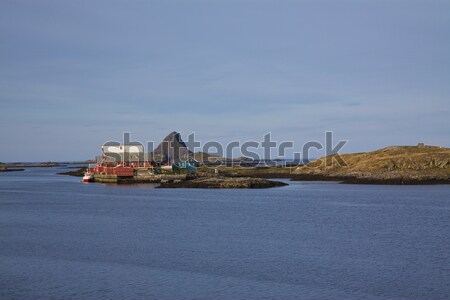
[59,131,287,188]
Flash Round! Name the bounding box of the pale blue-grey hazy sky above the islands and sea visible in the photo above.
[0,0,450,162]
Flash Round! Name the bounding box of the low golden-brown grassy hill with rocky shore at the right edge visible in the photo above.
[294,145,450,184]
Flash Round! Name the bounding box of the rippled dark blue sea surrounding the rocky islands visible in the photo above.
[0,168,450,299]
